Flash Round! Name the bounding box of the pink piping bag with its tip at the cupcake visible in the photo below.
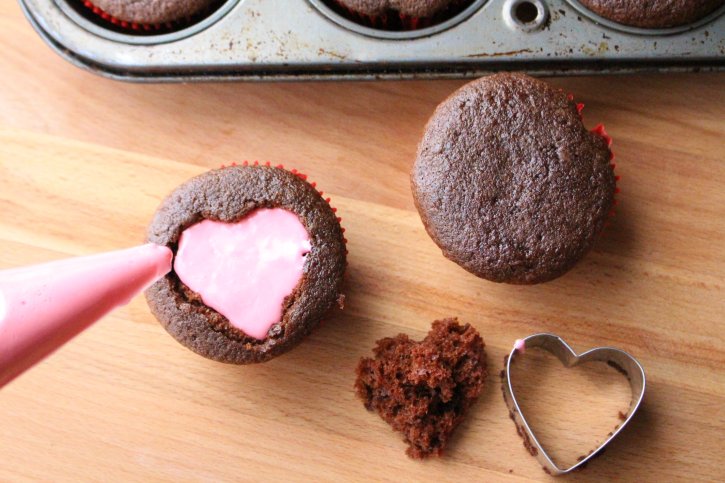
[0,244,173,387]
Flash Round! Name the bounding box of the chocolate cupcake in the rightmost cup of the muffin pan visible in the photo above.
[579,0,725,28]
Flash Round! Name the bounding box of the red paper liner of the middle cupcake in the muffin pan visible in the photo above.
[326,0,473,31]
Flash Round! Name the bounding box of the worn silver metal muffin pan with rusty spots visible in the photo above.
[19,0,725,82]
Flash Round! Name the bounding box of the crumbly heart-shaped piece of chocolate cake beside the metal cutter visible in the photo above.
[355,318,488,458]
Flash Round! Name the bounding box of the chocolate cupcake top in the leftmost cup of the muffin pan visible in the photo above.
[92,0,214,25]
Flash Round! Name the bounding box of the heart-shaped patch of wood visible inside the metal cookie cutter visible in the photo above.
[510,348,632,468]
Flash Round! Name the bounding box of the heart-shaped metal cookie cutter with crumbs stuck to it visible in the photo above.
[501,334,646,475]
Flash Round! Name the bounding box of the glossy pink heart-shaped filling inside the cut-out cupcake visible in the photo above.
[174,208,311,340]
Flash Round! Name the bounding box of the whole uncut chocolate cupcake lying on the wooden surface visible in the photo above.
[411,74,616,284]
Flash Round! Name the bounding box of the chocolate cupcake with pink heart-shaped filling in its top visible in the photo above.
[146,165,346,364]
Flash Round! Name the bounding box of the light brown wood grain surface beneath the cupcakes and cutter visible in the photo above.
[0,0,725,483]
